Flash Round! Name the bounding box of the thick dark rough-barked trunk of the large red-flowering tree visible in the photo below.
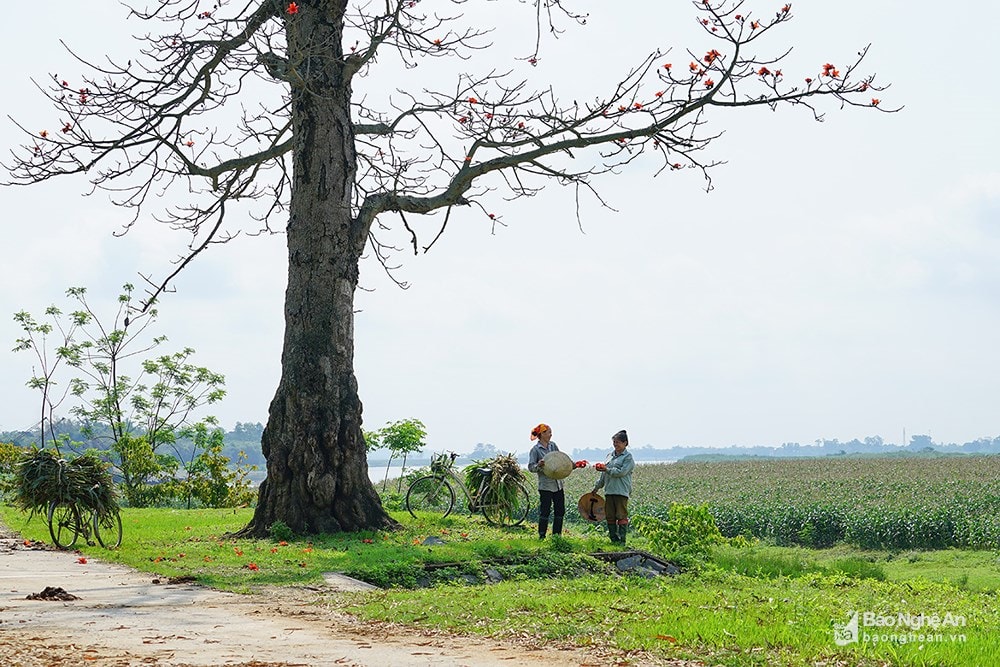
[240,9,397,537]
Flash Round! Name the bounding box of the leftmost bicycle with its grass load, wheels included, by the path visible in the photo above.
[15,448,122,549]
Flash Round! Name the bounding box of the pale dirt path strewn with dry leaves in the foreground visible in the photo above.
[0,526,692,667]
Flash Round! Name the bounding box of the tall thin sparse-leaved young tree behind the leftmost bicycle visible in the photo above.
[15,284,225,506]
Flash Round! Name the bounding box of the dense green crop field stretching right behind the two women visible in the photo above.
[567,456,1000,549]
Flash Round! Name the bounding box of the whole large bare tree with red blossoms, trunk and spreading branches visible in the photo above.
[8,0,885,535]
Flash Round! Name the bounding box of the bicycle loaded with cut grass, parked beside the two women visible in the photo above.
[406,452,531,527]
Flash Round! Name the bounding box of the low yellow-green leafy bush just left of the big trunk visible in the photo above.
[174,417,257,508]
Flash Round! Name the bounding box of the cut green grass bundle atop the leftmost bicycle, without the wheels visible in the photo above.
[15,448,118,513]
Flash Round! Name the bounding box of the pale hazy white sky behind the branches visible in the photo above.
[0,0,1000,451]
